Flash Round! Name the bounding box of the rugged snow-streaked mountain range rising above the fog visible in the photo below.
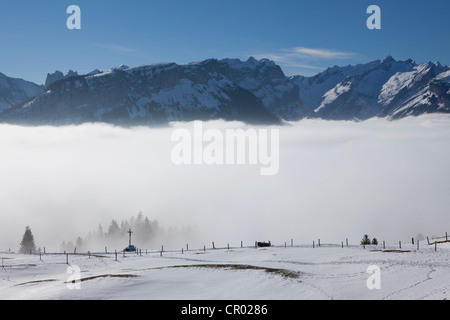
[0,56,450,126]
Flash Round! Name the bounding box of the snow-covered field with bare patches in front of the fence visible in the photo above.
[0,243,450,300]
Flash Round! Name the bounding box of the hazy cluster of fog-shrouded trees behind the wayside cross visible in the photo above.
[61,212,195,252]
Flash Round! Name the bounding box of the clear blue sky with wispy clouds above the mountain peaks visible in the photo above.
[0,0,450,83]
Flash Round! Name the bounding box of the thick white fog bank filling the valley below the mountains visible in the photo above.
[0,115,450,251]
